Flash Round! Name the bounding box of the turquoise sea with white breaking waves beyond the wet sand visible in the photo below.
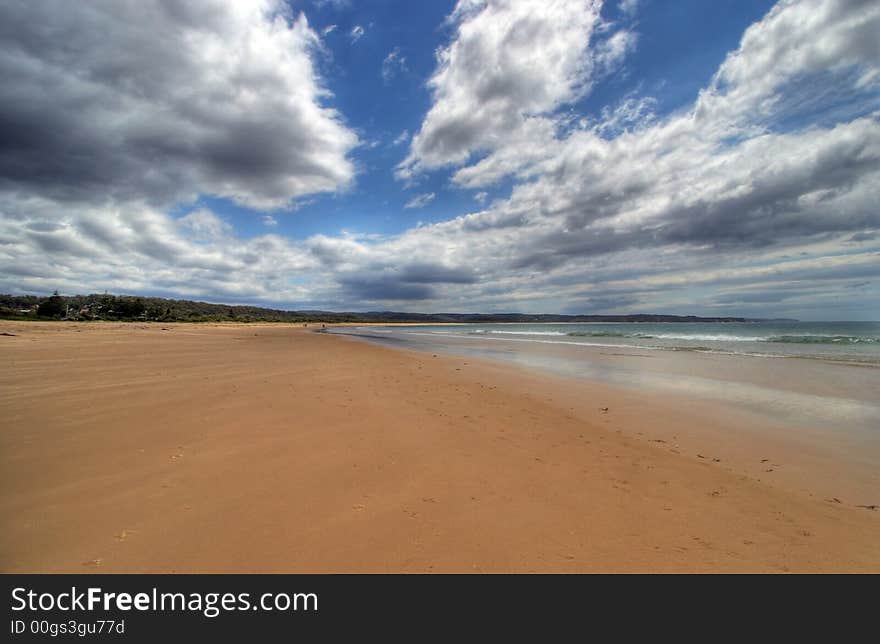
[360,322,880,364]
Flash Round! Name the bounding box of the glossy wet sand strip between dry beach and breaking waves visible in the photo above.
[331,325,880,505]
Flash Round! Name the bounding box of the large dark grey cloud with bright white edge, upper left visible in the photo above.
[0,0,358,208]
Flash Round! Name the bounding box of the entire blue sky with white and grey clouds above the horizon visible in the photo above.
[0,0,880,320]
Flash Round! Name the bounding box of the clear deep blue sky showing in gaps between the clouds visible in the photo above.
[203,0,773,239]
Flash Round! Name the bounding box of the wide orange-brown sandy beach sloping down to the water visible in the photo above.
[0,322,880,573]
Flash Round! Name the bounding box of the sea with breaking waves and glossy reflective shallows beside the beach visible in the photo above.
[328,321,880,432]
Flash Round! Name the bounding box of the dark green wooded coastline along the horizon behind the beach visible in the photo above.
[0,291,748,324]
